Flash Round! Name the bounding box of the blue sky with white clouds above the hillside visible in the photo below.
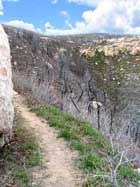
[0,0,140,35]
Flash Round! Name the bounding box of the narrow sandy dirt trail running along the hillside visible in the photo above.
[15,95,80,187]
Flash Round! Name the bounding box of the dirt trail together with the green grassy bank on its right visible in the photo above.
[15,95,140,187]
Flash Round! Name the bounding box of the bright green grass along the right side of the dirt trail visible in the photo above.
[32,106,140,187]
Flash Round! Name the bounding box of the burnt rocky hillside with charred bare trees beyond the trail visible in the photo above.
[4,26,140,155]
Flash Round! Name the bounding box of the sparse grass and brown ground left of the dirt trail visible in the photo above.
[0,112,41,187]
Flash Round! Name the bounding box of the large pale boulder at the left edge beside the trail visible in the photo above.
[0,25,14,147]
